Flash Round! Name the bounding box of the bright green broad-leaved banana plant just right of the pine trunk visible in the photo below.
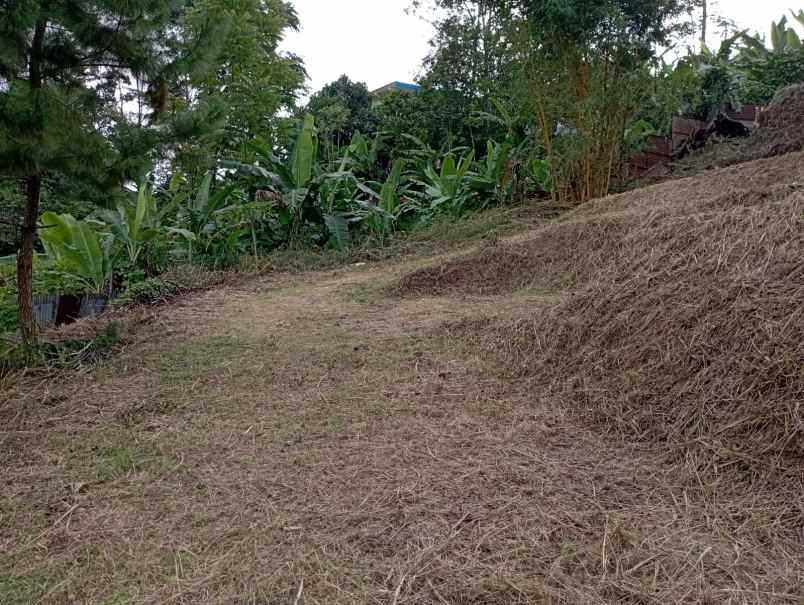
[39,212,114,293]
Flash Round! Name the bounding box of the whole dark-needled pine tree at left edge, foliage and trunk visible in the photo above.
[0,0,185,343]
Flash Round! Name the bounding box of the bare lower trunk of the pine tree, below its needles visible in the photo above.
[17,174,42,345]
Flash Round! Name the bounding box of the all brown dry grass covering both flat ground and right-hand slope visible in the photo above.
[0,157,804,605]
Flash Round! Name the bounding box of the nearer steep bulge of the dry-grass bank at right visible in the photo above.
[508,193,804,465]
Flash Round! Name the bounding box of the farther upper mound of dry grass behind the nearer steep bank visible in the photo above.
[406,154,804,297]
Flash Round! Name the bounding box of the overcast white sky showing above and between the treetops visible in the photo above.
[283,0,804,91]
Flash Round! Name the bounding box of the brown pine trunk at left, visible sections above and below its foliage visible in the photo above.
[17,18,47,345]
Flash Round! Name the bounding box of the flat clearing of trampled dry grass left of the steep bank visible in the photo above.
[0,248,796,605]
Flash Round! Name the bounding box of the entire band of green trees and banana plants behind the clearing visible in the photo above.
[0,0,804,342]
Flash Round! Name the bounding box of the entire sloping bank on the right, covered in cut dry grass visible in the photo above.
[420,155,804,477]
